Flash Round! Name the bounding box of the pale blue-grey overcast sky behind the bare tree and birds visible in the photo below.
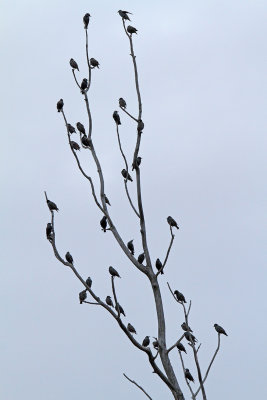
[0,0,267,400]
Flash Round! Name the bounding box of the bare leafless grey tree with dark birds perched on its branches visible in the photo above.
[45,10,229,400]
